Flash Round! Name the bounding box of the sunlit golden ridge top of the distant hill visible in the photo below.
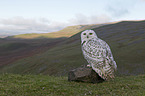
[9,24,103,39]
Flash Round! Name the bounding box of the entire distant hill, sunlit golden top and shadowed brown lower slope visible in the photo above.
[0,24,103,68]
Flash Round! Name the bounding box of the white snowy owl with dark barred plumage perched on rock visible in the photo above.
[81,30,117,80]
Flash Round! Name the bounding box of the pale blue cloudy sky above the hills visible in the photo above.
[0,0,145,35]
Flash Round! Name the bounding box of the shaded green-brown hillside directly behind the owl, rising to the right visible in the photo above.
[0,21,145,76]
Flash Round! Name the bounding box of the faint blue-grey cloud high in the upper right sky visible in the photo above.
[105,0,137,18]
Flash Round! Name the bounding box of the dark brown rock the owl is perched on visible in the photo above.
[68,68,104,83]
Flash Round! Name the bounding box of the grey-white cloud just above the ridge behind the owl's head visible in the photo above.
[69,14,111,25]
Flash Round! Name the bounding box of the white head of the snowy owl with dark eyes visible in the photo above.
[81,30,98,45]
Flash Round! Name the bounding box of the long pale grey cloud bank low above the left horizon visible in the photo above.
[0,17,65,35]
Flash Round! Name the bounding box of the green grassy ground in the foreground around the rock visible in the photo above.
[0,74,145,96]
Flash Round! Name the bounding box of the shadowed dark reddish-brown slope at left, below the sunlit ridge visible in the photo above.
[0,38,66,68]
